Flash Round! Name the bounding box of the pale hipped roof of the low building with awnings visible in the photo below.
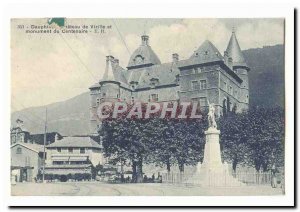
[47,137,102,149]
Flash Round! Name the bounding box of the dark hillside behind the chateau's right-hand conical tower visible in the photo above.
[244,45,284,107]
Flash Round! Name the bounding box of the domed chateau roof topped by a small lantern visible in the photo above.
[127,35,161,69]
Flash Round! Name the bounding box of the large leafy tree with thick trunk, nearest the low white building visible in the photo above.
[100,104,156,183]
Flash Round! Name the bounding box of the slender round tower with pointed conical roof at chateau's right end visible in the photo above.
[224,30,250,110]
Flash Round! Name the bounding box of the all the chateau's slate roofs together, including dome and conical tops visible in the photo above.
[90,36,244,90]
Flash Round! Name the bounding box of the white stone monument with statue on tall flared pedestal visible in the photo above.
[188,102,243,187]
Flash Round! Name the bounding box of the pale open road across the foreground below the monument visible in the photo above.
[11,182,282,196]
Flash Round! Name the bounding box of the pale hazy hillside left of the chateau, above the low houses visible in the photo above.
[11,92,90,135]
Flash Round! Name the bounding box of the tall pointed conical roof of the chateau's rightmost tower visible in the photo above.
[226,30,248,67]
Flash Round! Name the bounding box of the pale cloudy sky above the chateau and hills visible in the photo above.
[11,18,284,111]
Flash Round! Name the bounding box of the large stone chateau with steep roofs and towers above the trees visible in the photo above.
[89,31,250,133]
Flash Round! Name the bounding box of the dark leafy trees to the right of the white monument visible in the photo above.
[219,108,284,171]
